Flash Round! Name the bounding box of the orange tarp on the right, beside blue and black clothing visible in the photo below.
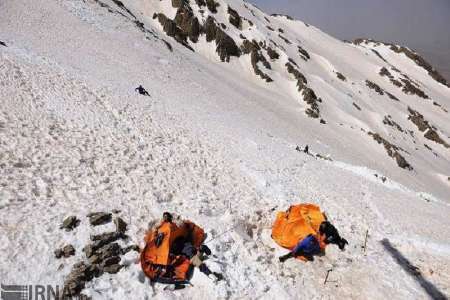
[272,203,326,250]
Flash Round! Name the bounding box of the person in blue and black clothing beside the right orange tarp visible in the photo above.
[279,221,348,262]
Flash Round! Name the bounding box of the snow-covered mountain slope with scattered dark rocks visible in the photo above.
[0,0,450,299]
